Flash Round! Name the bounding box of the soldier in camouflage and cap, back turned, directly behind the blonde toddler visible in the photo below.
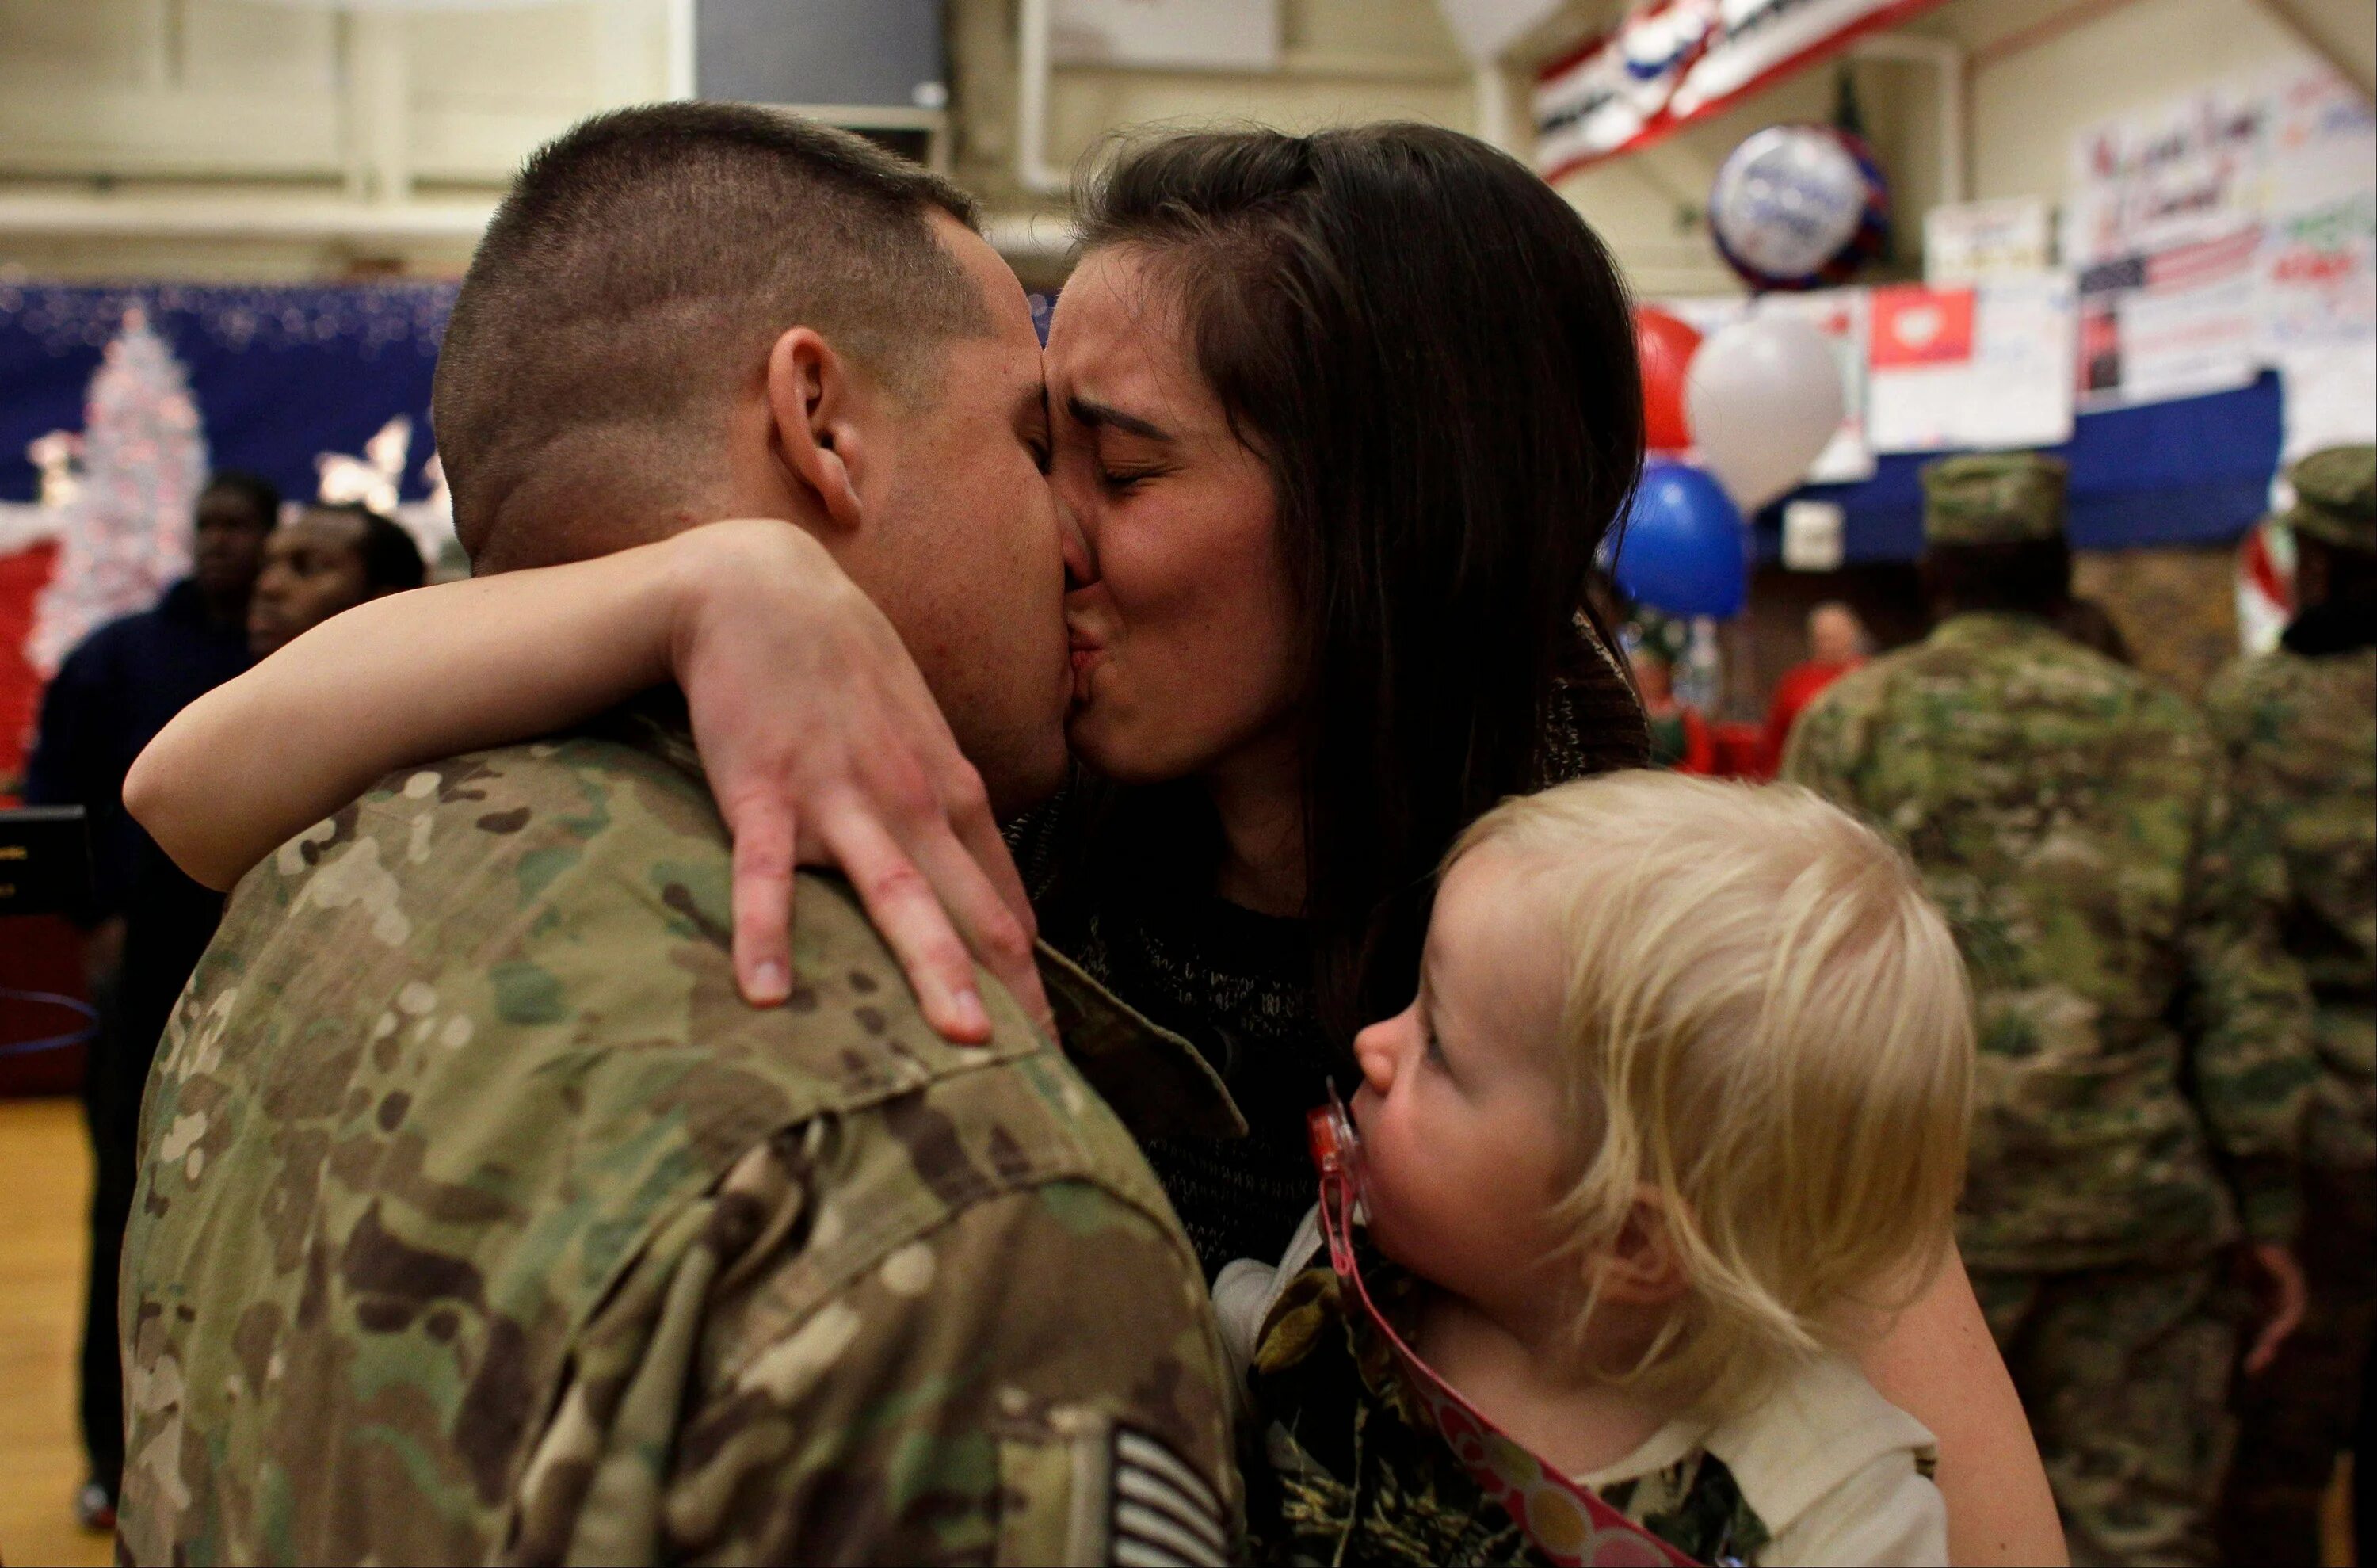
[1783,454,2315,1563]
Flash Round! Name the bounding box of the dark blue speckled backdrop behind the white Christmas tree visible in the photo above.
[0,280,454,502]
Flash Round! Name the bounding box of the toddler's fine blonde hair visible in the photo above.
[1445,773,1973,1409]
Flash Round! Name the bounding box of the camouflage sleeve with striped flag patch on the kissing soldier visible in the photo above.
[663,1181,1236,1563]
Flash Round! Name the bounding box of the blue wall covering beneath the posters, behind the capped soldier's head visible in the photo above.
[1757,373,2284,563]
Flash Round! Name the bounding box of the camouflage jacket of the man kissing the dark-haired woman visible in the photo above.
[119,715,1241,1563]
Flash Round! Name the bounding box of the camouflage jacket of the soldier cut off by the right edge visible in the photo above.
[2203,649,2377,1169]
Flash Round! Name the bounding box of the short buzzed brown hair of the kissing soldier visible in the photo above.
[433,102,989,570]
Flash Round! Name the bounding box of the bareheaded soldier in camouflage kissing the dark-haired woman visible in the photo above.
[121,105,1243,1563]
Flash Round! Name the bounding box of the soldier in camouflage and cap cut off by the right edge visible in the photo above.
[2206,447,2377,1563]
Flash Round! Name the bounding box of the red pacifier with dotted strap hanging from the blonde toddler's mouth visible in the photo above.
[1305,1083,1692,1568]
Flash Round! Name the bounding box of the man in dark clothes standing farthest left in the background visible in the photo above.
[24,471,280,1528]
